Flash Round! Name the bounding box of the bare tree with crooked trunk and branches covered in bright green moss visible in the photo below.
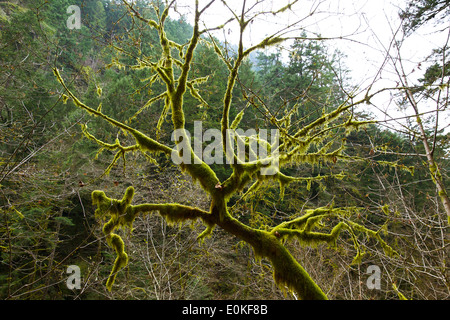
[54,0,395,299]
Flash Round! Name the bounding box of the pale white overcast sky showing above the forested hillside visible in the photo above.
[170,0,450,132]
